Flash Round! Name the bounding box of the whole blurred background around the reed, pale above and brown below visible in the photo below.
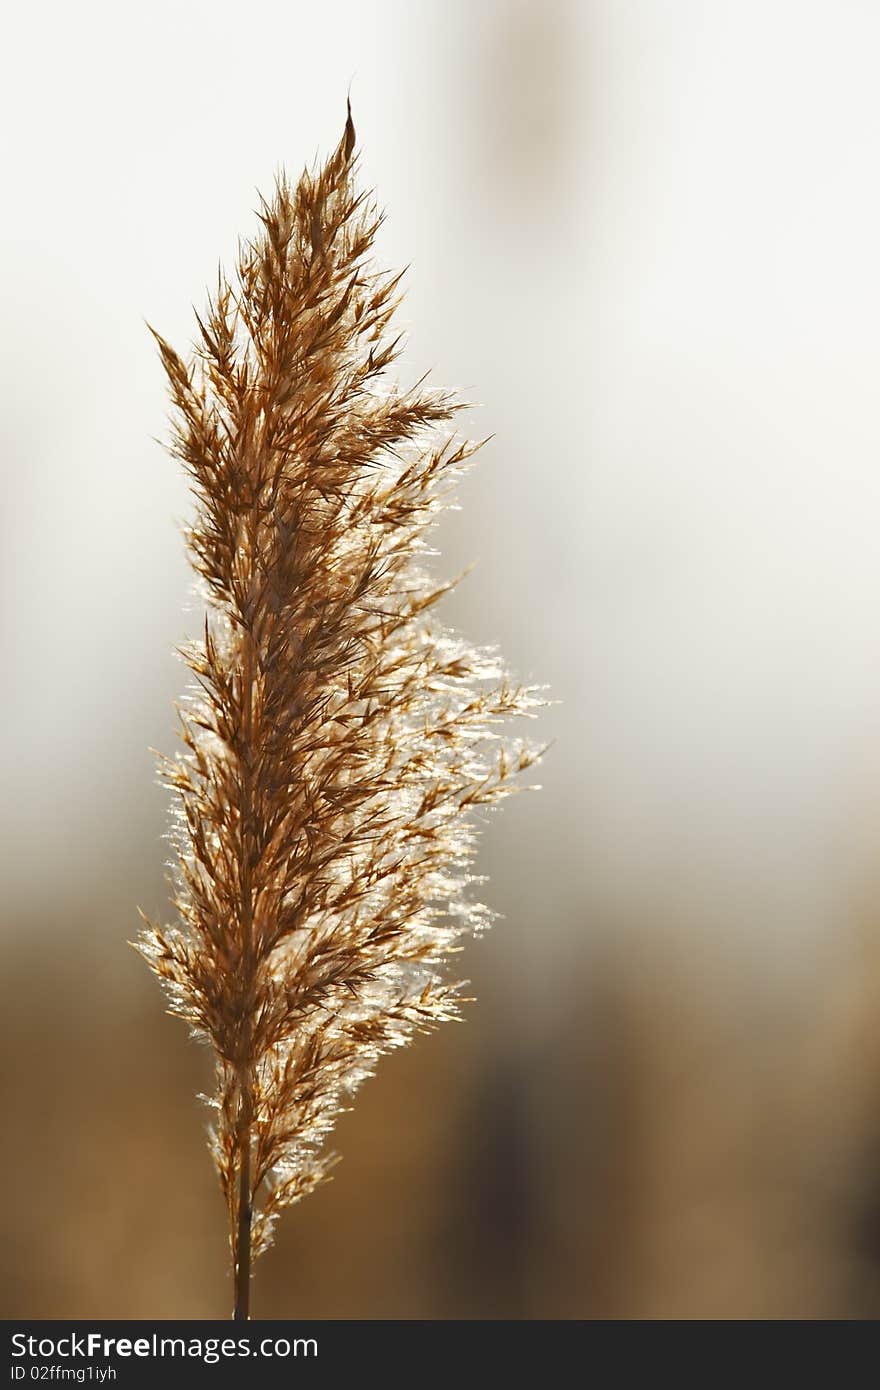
[8,0,880,1318]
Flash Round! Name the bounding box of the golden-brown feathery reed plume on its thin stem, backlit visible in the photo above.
[138,108,538,1318]
